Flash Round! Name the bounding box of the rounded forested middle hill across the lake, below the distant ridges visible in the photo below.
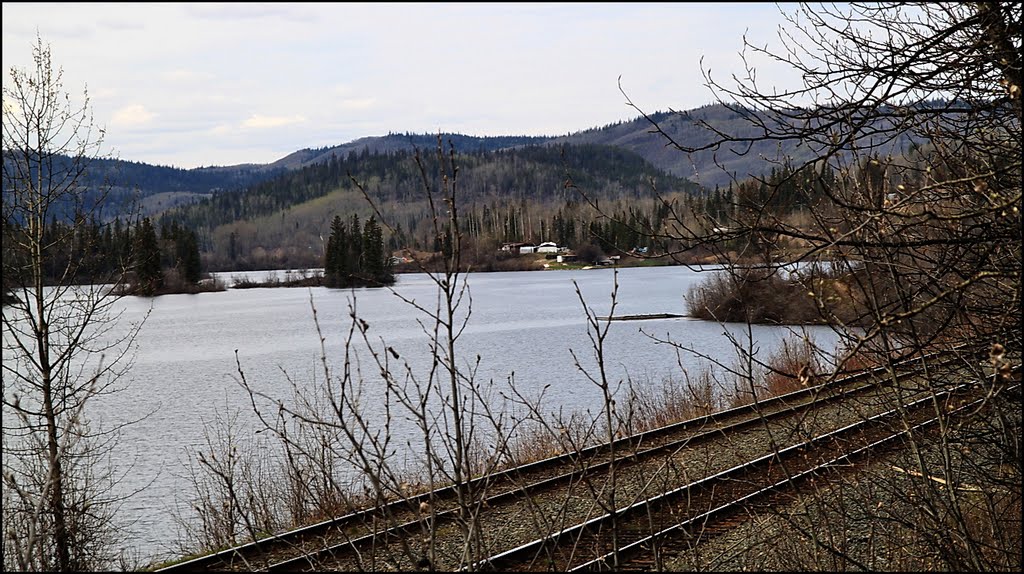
[163,139,698,270]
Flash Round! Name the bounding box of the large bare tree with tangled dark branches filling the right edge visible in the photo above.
[610,2,1022,570]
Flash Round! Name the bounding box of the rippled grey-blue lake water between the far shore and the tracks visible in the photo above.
[5,267,836,558]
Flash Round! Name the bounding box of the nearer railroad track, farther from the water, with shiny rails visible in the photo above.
[472,376,1019,572]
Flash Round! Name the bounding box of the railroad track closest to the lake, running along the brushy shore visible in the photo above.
[159,349,991,572]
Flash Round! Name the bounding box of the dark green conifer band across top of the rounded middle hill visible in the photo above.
[167,144,697,233]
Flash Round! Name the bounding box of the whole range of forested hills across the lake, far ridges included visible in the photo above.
[8,100,937,270]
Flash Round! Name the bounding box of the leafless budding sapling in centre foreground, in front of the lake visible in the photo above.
[174,138,528,570]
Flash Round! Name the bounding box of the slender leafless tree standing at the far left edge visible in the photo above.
[2,34,146,572]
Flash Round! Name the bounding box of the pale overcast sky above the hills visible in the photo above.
[3,2,798,168]
